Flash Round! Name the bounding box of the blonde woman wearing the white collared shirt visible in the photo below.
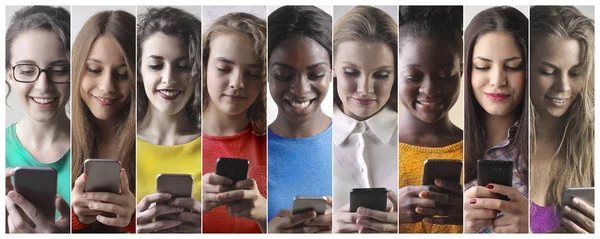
[333,6,398,233]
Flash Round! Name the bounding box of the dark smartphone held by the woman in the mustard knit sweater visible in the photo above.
[423,159,462,185]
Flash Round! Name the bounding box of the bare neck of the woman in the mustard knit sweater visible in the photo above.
[398,112,456,135]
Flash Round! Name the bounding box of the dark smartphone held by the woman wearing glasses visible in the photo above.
[13,167,56,222]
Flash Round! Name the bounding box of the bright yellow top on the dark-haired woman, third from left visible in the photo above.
[136,137,202,203]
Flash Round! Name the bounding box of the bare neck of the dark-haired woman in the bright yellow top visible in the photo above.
[138,104,199,145]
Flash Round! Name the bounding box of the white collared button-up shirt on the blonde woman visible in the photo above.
[333,104,398,210]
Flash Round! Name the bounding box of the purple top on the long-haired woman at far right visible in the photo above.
[529,201,560,233]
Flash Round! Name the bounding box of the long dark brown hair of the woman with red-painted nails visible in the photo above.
[464,6,529,184]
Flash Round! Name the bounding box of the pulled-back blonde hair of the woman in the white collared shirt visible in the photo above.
[333,6,398,112]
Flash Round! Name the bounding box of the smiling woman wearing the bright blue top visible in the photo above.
[268,6,332,233]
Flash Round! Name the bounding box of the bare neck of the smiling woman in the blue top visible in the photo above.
[269,107,331,138]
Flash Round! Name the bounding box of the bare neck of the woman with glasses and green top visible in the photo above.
[17,111,71,146]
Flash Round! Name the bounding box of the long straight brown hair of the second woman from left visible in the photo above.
[71,11,136,190]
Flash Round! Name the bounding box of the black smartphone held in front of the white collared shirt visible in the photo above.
[350,188,387,212]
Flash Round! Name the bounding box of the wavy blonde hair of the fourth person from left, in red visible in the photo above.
[202,12,267,135]
